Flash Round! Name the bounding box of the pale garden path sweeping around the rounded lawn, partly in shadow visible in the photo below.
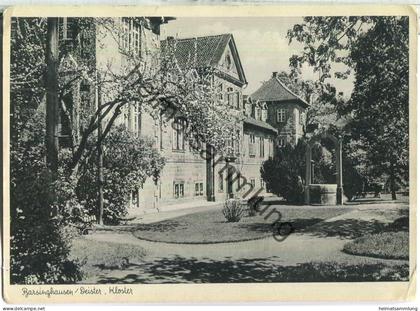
[79,200,408,283]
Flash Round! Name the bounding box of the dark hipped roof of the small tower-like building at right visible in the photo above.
[251,76,309,107]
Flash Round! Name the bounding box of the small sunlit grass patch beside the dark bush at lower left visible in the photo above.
[70,237,146,278]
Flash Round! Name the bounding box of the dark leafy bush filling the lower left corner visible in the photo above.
[10,115,81,284]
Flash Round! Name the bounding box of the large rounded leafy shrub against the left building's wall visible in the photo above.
[76,126,164,223]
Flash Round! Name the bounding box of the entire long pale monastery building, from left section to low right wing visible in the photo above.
[56,17,277,214]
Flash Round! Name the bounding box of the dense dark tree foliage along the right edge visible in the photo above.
[344,18,409,200]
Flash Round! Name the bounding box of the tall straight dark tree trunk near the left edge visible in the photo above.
[45,17,60,173]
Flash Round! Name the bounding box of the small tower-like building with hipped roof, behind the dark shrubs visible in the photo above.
[250,72,309,146]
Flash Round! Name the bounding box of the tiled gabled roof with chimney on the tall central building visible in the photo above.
[161,34,247,84]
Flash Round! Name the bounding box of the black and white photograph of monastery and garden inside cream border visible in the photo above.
[3,3,416,304]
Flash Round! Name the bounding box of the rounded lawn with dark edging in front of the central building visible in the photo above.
[133,206,352,244]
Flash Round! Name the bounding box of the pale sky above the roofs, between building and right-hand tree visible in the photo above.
[161,17,353,96]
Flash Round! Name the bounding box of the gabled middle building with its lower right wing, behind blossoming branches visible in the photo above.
[146,34,277,213]
